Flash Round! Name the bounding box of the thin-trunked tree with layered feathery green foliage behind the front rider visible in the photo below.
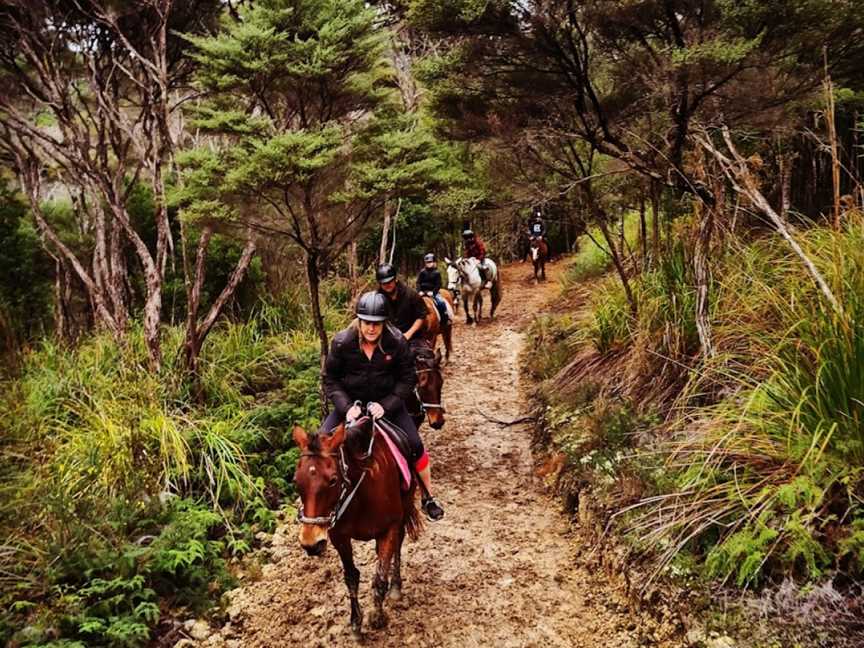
[180,0,452,362]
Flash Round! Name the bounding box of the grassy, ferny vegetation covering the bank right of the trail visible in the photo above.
[529,211,864,636]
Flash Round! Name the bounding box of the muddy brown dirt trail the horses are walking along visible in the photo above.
[199,264,681,648]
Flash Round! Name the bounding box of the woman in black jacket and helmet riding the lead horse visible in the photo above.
[321,292,444,520]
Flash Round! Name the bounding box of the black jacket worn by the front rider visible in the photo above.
[322,324,417,416]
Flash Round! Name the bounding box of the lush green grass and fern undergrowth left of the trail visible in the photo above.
[0,286,334,646]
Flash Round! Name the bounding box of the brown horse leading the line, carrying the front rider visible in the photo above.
[294,417,421,638]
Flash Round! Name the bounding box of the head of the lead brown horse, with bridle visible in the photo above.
[294,424,347,556]
